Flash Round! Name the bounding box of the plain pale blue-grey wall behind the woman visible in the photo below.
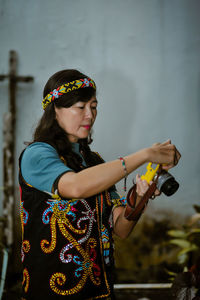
[0,0,200,214]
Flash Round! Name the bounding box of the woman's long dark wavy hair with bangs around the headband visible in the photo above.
[33,69,102,171]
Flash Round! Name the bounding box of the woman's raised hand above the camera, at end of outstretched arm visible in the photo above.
[149,140,181,170]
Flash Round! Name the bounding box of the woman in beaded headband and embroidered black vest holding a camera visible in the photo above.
[19,70,180,300]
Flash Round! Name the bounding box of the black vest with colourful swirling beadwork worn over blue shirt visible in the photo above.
[19,157,113,300]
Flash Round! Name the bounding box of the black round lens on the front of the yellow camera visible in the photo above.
[157,170,179,196]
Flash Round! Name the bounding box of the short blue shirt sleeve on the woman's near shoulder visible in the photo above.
[21,142,73,193]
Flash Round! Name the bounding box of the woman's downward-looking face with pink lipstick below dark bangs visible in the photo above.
[55,96,97,143]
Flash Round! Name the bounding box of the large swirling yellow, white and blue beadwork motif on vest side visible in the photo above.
[41,192,101,295]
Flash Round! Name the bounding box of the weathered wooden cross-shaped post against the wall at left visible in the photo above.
[0,50,33,247]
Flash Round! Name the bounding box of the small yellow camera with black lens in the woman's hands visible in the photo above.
[141,163,179,196]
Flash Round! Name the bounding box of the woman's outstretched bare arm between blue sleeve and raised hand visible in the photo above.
[58,149,148,198]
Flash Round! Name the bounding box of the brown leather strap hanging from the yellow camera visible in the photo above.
[124,182,156,221]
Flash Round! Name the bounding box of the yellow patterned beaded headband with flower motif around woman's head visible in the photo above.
[42,78,96,109]
